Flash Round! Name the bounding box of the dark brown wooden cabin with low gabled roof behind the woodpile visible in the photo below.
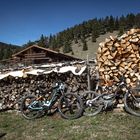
[12,45,81,64]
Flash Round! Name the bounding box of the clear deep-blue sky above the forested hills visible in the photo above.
[0,0,140,45]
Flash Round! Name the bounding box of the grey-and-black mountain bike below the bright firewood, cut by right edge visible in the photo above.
[82,78,140,117]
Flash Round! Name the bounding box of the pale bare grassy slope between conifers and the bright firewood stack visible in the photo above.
[60,31,118,59]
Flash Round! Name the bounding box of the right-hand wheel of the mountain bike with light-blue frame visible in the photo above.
[58,93,83,119]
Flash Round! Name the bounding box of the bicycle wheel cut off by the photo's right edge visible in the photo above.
[124,92,140,117]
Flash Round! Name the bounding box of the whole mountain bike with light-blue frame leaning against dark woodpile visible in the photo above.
[20,82,83,119]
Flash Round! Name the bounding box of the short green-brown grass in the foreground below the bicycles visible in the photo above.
[0,112,140,140]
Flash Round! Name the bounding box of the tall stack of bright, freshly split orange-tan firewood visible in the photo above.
[97,29,140,87]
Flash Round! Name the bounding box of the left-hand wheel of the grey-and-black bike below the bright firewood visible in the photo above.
[82,91,103,116]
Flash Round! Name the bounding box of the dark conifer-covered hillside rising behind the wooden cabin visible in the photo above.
[0,13,140,59]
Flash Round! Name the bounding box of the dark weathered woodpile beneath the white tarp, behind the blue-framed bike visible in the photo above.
[0,72,87,111]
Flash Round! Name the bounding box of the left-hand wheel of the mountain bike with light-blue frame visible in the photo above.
[20,95,40,119]
